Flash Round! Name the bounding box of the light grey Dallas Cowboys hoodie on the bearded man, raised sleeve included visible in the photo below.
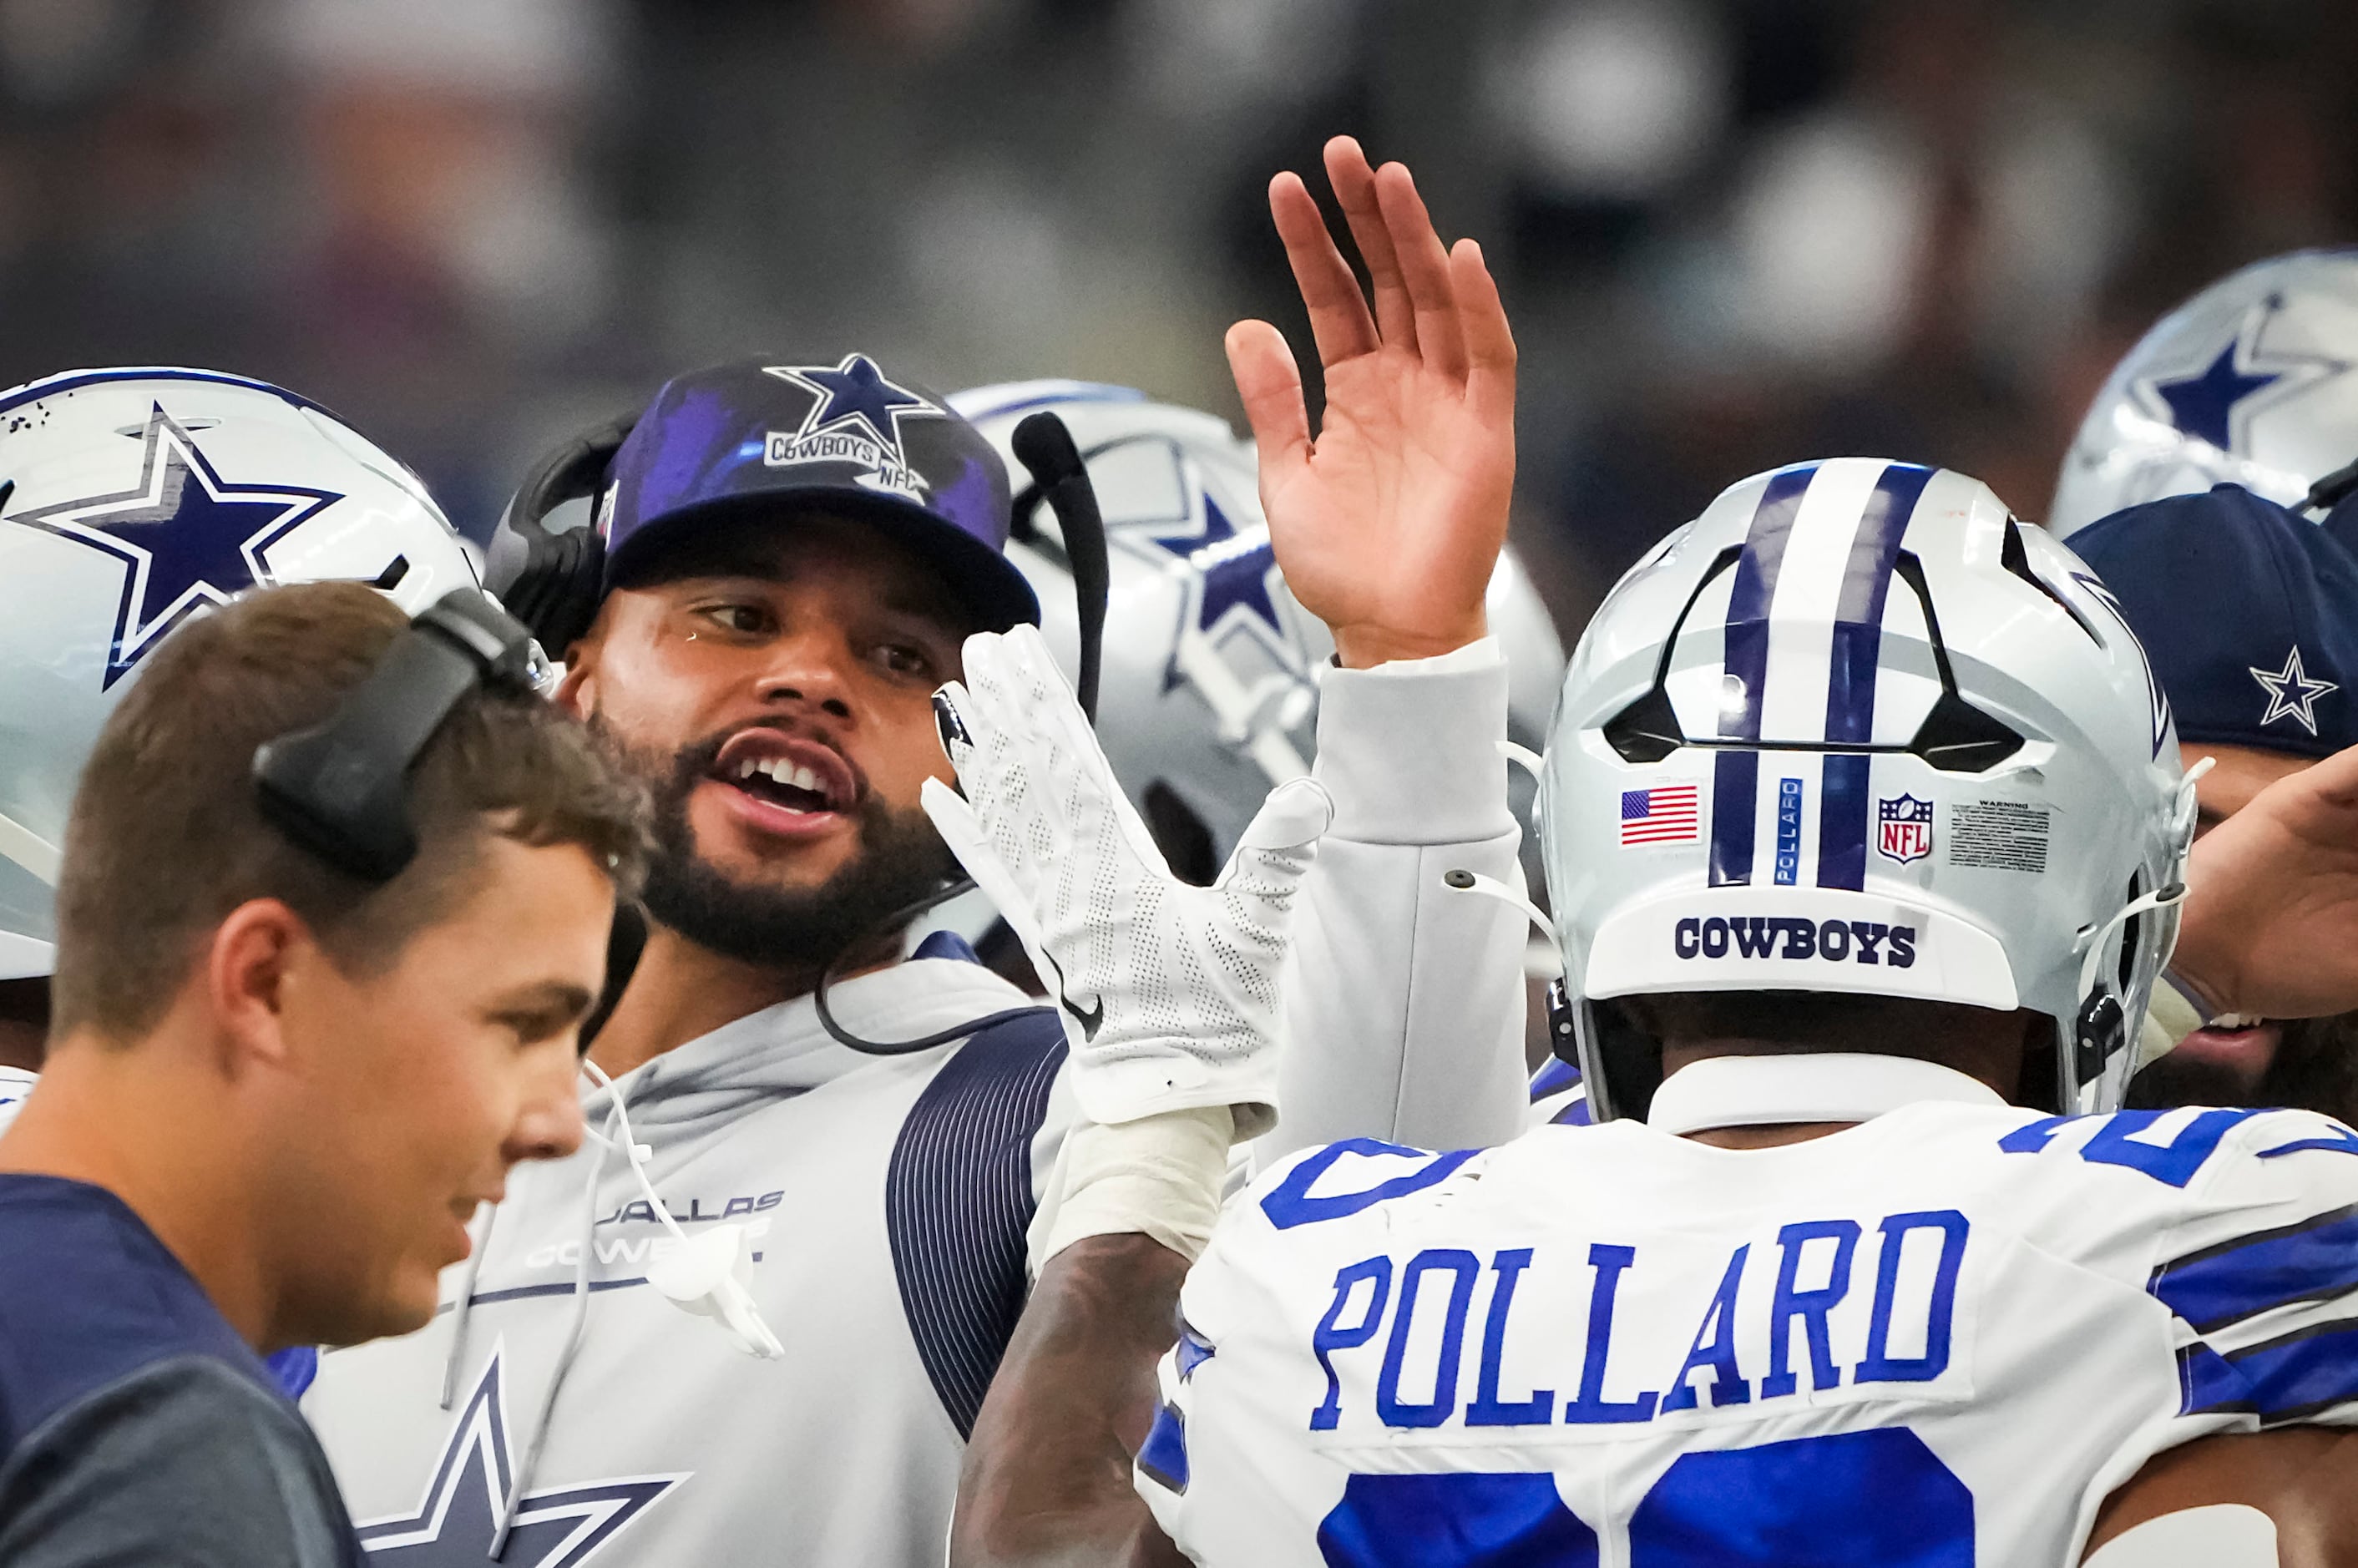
[304,646,1526,1568]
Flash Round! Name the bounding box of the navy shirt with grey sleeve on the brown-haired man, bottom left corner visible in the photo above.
[0,1174,361,1568]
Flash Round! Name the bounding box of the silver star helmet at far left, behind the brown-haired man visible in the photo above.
[0,368,474,979]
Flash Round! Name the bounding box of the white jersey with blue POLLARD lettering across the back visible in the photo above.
[1139,1059,2358,1568]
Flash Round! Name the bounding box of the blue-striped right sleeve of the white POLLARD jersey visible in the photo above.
[2148,1110,2358,1429]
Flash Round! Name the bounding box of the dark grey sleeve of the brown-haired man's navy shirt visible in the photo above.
[0,1356,358,1568]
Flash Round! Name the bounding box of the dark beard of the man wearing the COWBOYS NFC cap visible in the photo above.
[592,719,958,976]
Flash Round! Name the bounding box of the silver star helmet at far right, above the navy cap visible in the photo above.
[2047,250,2358,538]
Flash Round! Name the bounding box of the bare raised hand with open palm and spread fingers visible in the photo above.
[1228,137,1514,667]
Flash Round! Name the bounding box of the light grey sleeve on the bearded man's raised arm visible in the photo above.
[1254,639,1528,1167]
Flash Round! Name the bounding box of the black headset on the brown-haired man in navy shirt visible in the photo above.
[252,587,547,884]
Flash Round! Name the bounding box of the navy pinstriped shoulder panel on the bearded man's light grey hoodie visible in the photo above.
[884,1007,1065,1439]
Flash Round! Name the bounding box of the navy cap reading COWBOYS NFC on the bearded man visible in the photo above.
[599,354,1040,632]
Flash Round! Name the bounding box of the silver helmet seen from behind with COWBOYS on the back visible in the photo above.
[1540,458,2193,1118]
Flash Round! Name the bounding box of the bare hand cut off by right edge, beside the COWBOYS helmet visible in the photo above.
[2169,747,2358,1019]
